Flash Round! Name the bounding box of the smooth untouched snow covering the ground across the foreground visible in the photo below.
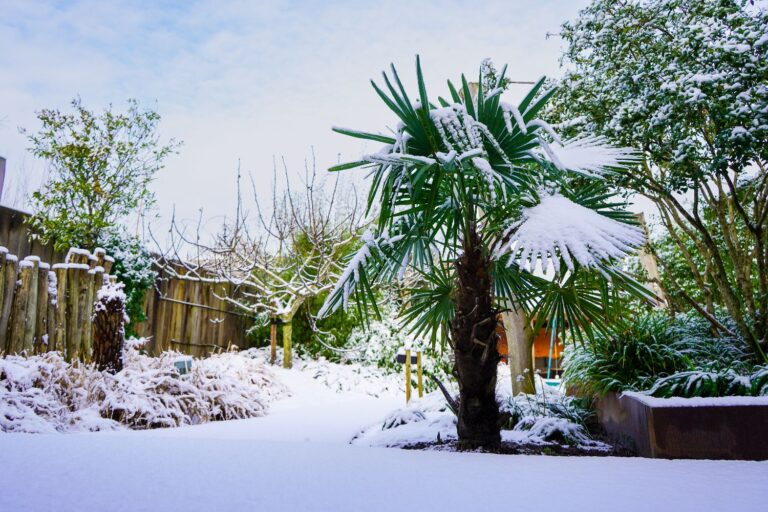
[0,358,768,512]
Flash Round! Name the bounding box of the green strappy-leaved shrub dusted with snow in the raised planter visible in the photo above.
[564,312,753,396]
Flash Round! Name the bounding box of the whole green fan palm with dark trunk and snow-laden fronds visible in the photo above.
[320,57,646,446]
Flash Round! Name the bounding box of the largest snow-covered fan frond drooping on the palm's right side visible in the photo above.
[496,194,645,272]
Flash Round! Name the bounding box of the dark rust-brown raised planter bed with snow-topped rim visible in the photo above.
[597,393,768,460]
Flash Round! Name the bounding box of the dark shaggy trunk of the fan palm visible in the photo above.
[451,231,501,449]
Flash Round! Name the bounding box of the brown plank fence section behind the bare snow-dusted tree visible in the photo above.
[135,269,251,357]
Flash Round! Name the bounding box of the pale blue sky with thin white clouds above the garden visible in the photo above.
[0,0,586,234]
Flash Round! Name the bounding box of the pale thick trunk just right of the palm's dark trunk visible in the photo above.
[501,309,535,395]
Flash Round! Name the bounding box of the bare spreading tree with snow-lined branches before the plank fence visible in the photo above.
[157,154,368,368]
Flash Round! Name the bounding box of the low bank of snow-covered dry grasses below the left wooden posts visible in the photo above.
[0,343,287,432]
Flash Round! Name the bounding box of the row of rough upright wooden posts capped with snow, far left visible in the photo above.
[0,247,114,362]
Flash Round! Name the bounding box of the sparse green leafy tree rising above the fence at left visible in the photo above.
[22,98,179,250]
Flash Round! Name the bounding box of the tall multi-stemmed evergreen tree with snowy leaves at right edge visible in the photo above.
[552,0,768,360]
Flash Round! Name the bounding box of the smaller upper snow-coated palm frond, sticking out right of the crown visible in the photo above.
[541,135,639,176]
